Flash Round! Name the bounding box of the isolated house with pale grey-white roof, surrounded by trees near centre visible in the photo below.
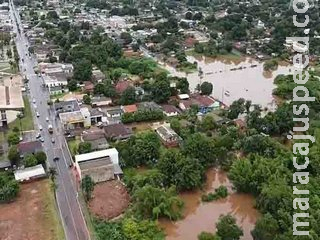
[155,124,181,147]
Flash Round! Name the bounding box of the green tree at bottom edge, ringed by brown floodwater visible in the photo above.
[216,214,243,240]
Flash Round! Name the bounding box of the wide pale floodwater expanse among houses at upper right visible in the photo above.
[164,56,293,108]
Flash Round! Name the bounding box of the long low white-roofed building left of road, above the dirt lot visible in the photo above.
[14,164,46,182]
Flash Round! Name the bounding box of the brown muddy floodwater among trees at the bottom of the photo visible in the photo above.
[160,169,259,240]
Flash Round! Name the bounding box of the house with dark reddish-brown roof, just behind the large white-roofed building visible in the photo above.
[104,123,132,141]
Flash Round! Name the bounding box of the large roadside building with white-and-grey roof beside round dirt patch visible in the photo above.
[75,148,123,183]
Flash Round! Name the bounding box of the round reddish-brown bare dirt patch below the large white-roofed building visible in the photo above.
[89,180,130,220]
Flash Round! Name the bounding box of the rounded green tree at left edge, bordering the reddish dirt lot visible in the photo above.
[0,172,20,203]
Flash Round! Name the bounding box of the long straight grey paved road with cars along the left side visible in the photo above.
[10,1,90,240]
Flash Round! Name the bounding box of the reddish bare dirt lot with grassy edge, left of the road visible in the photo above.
[0,179,63,240]
